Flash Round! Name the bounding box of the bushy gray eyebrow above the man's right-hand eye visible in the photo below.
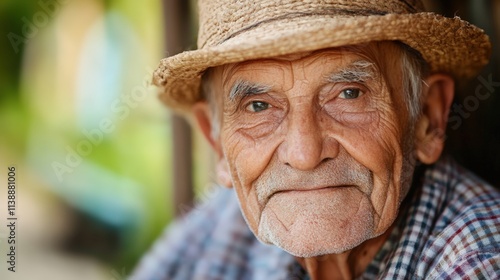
[327,60,376,83]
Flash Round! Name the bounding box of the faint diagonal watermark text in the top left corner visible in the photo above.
[7,0,69,54]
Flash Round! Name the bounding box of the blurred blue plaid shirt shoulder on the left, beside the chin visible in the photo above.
[131,187,287,280]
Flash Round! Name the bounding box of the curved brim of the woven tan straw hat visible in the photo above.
[153,13,491,111]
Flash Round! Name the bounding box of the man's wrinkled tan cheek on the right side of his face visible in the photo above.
[330,106,404,232]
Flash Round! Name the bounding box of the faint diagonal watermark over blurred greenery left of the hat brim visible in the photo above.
[51,71,152,182]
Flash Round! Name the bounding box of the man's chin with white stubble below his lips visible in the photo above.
[256,197,377,258]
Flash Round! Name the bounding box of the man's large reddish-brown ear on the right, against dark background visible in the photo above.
[415,74,455,164]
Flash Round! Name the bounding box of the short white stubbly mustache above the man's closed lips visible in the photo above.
[253,155,373,207]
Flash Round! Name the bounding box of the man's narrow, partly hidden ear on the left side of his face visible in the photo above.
[192,101,232,188]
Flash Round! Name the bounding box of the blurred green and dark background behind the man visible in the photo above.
[0,0,500,280]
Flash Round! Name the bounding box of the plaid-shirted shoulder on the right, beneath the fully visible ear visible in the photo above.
[420,161,500,279]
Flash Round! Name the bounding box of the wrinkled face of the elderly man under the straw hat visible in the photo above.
[213,43,413,257]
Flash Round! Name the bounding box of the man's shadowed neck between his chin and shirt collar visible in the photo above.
[296,227,392,280]
